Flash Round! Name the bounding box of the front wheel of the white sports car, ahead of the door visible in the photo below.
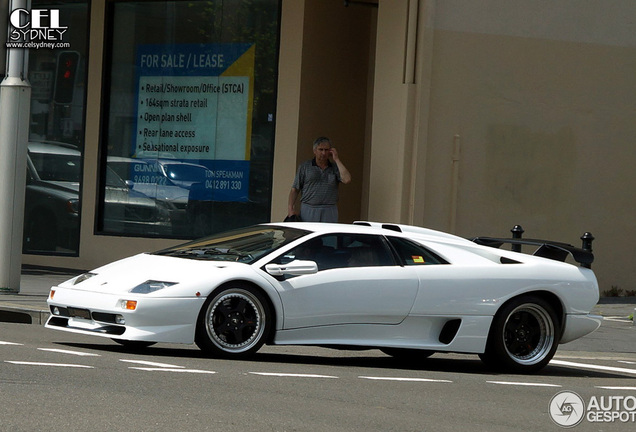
[195,283,271,358]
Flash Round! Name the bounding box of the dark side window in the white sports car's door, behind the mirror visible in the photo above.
[274,234,396,271]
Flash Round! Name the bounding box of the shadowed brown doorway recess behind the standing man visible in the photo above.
[288,0,376,222]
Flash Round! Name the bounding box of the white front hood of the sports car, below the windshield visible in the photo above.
[59,253,252,296]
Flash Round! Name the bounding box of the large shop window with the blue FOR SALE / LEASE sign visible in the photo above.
[97,0,280,238]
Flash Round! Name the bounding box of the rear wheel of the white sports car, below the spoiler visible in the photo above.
[479,296,561,373]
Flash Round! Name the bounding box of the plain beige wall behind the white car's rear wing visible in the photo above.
[369,0,636,290]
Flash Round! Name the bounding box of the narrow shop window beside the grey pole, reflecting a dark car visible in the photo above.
[23,0,89,256]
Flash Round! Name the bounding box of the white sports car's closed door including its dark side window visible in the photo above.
[273,234,419,329]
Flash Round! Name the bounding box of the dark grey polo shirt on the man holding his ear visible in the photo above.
[292,158,342,206]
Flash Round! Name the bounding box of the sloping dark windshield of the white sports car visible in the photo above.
[153,225,309,264]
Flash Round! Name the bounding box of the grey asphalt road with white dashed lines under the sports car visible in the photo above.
[0,319,636,432]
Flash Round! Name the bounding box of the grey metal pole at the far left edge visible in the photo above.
[0,0,31,293]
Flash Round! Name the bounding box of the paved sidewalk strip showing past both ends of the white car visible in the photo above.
[0,267,636,324]
